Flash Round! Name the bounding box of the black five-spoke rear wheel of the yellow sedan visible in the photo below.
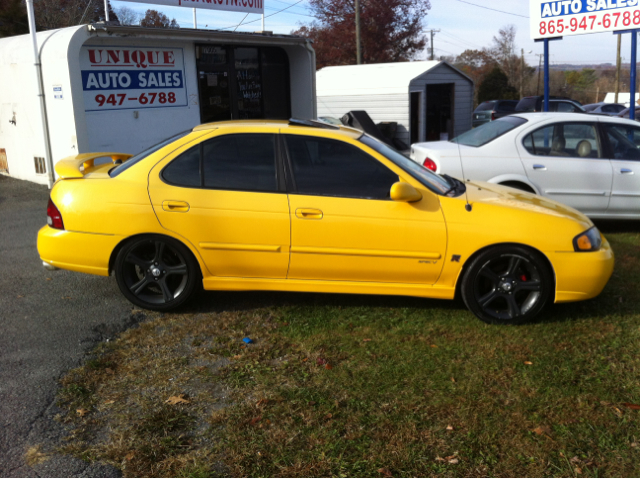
[115,235,202,311]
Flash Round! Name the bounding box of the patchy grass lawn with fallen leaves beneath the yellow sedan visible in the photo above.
[53,224,640,477]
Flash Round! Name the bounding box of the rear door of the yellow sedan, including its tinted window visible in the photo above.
[149,131,290,278]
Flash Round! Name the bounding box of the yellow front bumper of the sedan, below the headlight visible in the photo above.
[547,239,615,303]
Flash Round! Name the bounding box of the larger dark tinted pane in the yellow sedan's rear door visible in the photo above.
[202,134,278,191]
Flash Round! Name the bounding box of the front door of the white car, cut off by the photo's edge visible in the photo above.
[600,122,640,216]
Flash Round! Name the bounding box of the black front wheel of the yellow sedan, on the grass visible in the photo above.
[460,245,555,324]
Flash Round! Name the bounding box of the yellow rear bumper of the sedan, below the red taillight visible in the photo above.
[38,226,122,276]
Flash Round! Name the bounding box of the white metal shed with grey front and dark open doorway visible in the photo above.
[316,61,473,144]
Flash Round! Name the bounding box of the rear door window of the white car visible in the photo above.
[523,123,602,158]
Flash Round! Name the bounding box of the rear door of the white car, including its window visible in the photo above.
[519,122,612,214]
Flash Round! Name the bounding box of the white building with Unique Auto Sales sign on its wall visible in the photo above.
[0,24,316,184]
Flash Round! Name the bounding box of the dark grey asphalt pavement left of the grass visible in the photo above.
[0,175,136,477]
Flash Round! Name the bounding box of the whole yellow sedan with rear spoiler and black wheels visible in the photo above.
[38,120,614,324]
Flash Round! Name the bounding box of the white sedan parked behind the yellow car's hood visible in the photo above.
[411,113,640,219]
